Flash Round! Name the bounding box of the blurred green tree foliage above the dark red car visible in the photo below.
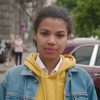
[56,0,100,37]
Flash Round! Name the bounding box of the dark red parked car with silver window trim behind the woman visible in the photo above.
[63,38,100,100]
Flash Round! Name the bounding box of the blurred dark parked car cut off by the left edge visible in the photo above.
[0,38,9,63]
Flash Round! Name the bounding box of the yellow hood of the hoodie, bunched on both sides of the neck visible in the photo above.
[24,53,76,77]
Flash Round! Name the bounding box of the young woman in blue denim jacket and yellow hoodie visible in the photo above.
[0,6,97,100]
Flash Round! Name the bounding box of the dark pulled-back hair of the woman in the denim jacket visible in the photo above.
[33,5,72,35]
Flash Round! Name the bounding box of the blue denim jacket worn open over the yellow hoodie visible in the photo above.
[0,65,97,100]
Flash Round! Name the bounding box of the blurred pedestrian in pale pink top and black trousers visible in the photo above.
[14,35,24,65]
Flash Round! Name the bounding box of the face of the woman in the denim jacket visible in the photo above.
[34,17,68,60]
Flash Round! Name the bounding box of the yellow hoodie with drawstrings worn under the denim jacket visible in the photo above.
[24,54,75,100]
